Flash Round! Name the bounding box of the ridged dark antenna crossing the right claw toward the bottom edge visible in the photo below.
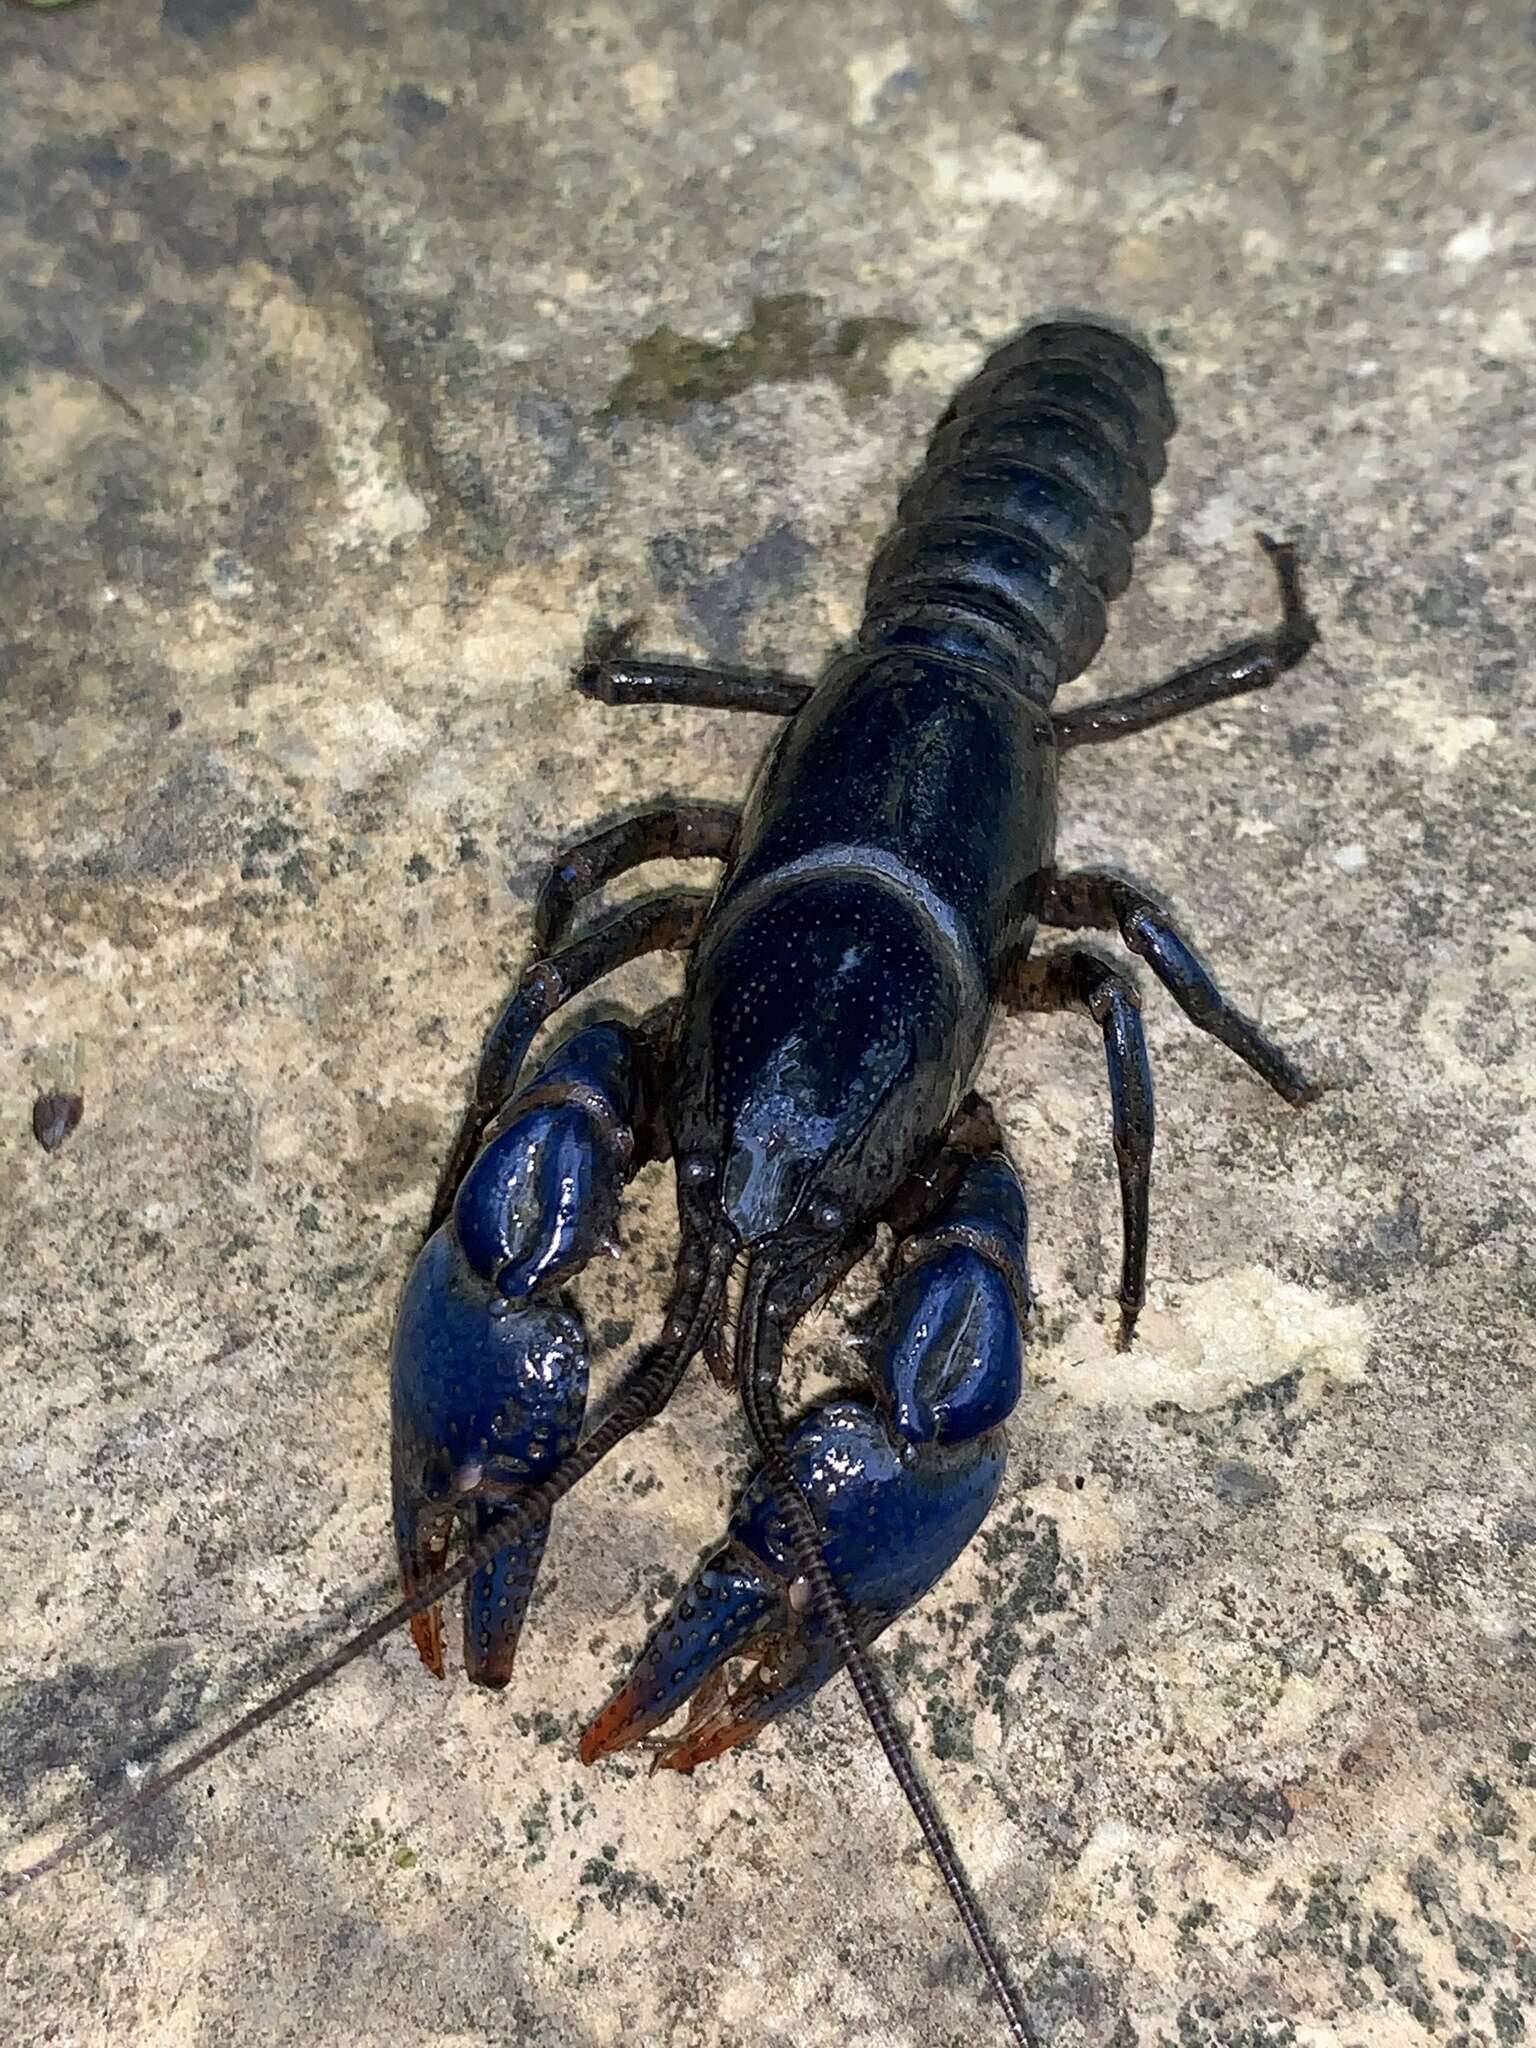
[737,1268,1040,2048]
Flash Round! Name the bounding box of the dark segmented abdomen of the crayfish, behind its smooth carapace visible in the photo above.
[858,322,1174,700]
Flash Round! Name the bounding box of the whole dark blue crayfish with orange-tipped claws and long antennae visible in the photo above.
[12,322,1317,2042]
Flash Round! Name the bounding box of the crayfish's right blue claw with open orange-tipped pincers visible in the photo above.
[582,1157,1028,1772]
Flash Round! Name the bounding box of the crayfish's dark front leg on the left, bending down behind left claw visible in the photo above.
[428,889,709,1235]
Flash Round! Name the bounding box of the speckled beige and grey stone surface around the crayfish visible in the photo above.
[0,0,1536,2048]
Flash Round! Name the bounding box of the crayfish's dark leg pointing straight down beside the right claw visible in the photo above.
[1001,946,1153,1350]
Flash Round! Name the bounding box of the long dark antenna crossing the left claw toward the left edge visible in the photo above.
[0,1249,729,1898]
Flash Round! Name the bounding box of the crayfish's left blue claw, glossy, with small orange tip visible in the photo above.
[391,1024,639,1688]
